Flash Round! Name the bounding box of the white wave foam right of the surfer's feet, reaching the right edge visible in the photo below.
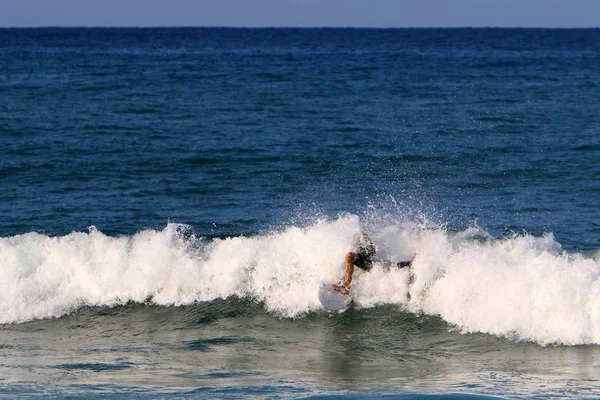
[412,231,600,344]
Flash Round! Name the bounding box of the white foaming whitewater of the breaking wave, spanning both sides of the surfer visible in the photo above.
[0,215,600,345]
